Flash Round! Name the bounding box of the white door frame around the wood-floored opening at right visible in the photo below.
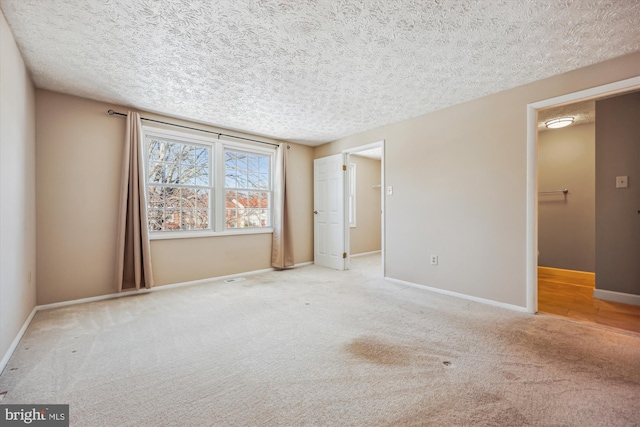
[526,76,640,314]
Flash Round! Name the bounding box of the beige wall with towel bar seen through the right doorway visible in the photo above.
[538,123,596,272]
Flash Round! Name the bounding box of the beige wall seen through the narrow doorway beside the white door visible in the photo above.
[349,154,382,255]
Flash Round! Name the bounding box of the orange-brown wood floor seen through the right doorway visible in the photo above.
[538,267,640,335]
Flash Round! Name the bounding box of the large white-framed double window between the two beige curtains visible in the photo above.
[144,127,274,238]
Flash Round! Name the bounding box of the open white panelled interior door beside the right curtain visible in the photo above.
[313,154,346,270]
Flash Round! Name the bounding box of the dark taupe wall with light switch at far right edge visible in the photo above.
[596,92,640,295]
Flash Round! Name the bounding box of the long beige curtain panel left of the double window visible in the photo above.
[116,111,153,292]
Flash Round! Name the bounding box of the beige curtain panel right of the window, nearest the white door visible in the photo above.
[271,144,294,268]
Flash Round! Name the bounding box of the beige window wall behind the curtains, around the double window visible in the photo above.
[36,90,313,304]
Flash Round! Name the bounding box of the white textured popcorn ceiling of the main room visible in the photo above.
[0,0,640,145]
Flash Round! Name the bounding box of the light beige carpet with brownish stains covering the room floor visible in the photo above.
[0,255,640,427]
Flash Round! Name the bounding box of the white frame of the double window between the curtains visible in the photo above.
[142,125,275,240]
